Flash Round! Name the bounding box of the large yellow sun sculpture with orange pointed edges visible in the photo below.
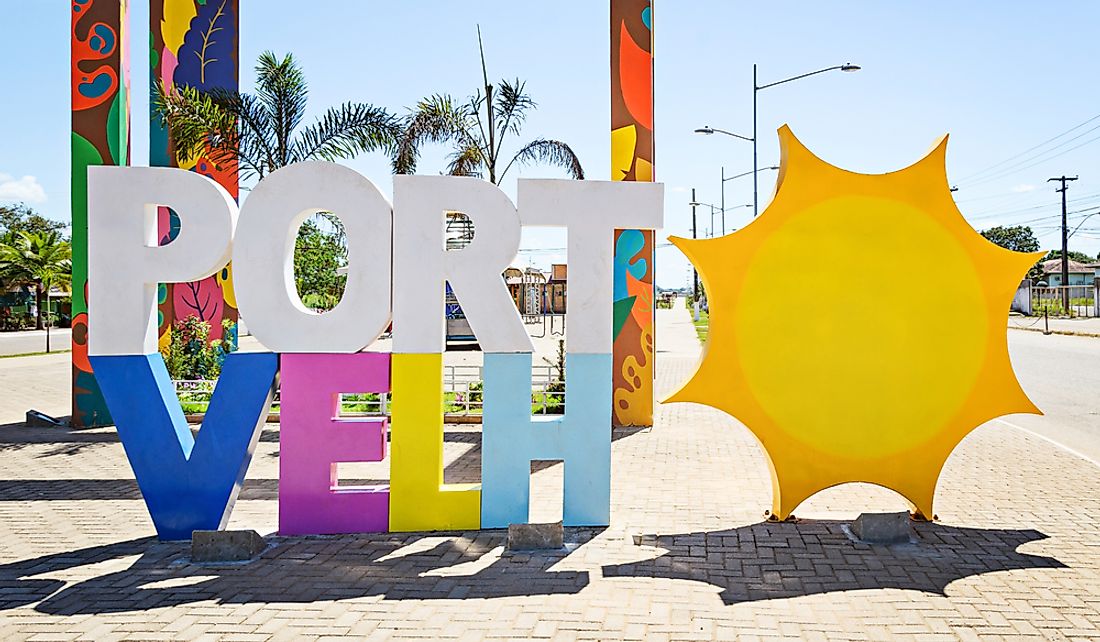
[666,125,1042,519]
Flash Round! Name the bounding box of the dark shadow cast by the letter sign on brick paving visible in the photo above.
[0,529,598,616]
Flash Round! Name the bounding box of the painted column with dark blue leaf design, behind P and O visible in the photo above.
[149,0,240,350]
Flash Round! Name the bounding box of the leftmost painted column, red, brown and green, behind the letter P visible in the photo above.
[72,0,130,427]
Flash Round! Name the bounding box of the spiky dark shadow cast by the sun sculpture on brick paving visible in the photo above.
[603,521,1066,605]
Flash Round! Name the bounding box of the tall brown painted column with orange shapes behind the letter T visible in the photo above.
[611,0,655,425]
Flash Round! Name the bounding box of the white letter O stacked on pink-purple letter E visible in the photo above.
[233,162,393,534]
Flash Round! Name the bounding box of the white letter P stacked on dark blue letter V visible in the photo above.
[88,167,278,540]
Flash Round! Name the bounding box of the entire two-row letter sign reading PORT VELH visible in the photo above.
[88,163,662,539]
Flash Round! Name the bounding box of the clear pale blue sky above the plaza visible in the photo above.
[0,0,1100,287]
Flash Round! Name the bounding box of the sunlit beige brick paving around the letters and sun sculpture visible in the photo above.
[0,310,1100,641]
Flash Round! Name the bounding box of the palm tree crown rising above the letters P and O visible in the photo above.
[154,52,400,180]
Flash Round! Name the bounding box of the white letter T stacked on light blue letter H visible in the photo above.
[482,180,663,528]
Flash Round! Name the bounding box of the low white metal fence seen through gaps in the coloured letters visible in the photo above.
[173,365,565,421]
